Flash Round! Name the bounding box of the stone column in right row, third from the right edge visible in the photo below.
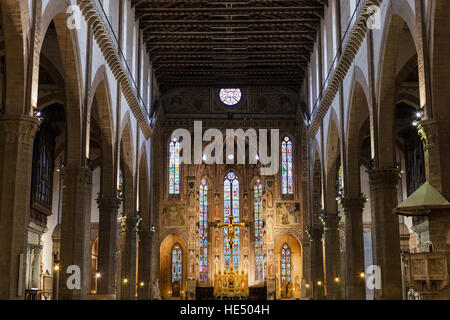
[340,198,366,300]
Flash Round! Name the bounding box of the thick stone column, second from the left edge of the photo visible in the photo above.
[59,165,92,300]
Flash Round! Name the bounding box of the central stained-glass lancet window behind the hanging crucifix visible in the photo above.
[223,172,239,270]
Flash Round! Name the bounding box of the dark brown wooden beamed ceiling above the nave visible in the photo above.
[131,0,327,91]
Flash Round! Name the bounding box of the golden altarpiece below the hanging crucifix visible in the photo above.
[214,265,249,299]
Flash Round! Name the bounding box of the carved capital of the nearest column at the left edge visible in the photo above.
[0,114,40,145]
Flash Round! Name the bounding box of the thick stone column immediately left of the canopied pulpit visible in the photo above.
[369,168,403,300]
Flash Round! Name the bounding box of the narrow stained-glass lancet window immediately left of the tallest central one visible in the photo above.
[199,180,208,281]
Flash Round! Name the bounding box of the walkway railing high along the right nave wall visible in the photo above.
[311,0,366,119]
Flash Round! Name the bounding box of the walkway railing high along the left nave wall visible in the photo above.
[93,0,151,123]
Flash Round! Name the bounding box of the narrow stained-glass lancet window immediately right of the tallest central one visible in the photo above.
[253,180,264,281]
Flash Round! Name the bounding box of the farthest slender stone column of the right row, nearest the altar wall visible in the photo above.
[307,223,325,300]
